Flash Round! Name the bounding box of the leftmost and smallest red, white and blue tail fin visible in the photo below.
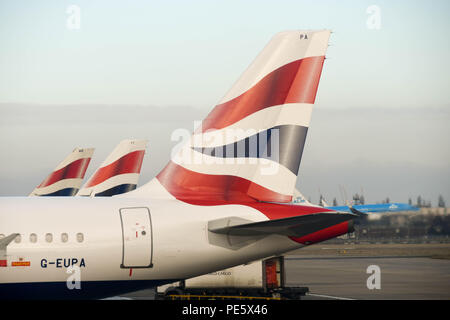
[30,148,94,197]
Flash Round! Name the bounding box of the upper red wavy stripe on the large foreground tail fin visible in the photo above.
[201,56,325,132]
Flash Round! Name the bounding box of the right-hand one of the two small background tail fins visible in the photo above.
[77,140,147,197]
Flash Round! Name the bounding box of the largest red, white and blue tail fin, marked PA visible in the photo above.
[128,30,330,202]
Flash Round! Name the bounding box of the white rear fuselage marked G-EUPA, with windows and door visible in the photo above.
[0,197,301,298]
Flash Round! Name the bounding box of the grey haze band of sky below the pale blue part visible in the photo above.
[0,104,450,204]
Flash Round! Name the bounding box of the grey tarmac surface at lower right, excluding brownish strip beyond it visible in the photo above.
[286,256,450,300]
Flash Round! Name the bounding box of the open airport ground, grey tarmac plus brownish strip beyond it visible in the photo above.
[121,244,450,300]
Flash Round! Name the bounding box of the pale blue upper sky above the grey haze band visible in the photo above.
[0,0,450,108]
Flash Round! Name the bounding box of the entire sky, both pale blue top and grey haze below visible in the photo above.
[0,0,450,203]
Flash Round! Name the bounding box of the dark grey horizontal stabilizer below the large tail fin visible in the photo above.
[208,212,357,237]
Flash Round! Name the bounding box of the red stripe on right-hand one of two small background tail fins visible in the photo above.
[86,150,145,188]
